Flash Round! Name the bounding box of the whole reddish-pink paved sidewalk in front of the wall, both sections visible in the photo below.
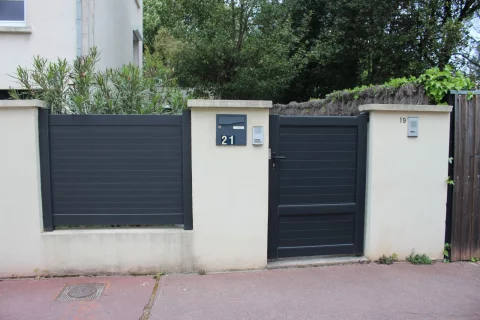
[0,263,480,320]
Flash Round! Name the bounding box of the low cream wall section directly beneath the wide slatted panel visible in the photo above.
[41,229,195,275]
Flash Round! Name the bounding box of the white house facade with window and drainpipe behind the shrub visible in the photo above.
[0,0,143,94]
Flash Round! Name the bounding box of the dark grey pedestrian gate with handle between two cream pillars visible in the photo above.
[268,115,368,259]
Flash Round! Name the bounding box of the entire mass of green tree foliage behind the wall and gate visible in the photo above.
[145,0,480,102]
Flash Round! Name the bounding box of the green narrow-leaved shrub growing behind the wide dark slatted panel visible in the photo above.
[10,48,188,114]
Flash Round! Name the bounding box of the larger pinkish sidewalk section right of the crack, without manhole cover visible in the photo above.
[150,263,480,320]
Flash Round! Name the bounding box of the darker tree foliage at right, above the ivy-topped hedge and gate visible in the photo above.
[288,0,480,99]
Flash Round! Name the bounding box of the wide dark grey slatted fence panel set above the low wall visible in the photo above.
[39,109,193,231]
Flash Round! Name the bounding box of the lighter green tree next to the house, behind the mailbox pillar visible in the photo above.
[146,0,302,99]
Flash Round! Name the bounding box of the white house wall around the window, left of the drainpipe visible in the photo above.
[0,0,76,90]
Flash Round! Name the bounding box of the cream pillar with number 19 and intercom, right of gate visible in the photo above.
[360,104,452,260]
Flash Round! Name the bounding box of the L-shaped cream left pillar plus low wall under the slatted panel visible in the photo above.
[0,100,195,278]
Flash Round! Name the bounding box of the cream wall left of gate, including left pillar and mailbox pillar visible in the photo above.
[0,100,271,278]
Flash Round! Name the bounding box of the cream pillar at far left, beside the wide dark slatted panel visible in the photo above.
[0,100,43,277]
